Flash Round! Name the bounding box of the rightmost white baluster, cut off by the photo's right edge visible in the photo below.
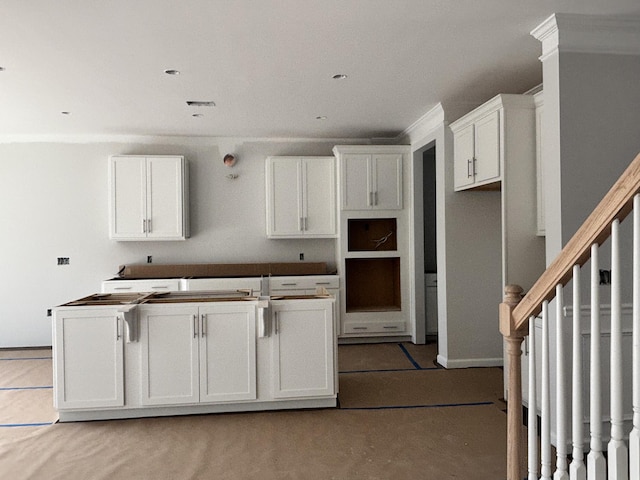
[629,195,640,480]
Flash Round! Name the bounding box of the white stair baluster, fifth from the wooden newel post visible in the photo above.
[587,244,607,480]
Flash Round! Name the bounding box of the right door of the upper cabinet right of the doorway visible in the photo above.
[475,111,500,184]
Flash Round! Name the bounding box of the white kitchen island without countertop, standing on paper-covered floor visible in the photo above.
[53,291,338,422]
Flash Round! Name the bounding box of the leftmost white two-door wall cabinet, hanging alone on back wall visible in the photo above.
[109,155,189,240]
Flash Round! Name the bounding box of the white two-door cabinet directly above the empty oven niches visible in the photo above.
[334,145,408,210]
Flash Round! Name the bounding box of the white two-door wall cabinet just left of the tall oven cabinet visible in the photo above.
[266,157,337,238]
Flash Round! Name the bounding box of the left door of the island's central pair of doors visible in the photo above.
[138,305,200,405]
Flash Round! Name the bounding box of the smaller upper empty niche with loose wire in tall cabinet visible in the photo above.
[347,218,398,252]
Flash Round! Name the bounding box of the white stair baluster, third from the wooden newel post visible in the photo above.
[553,285,569,480]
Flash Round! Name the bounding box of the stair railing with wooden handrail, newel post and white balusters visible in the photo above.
[500,154,640,480]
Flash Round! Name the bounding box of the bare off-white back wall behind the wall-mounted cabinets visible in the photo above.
[0,138,350,348]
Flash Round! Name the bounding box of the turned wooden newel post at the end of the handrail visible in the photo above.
[500,285,528,480]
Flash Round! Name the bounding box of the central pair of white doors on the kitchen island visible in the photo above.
[139,302,256,405]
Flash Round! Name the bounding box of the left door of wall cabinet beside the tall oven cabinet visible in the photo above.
[267,157,303,237]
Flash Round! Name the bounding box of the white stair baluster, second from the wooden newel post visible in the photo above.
[540,300,551,480]
